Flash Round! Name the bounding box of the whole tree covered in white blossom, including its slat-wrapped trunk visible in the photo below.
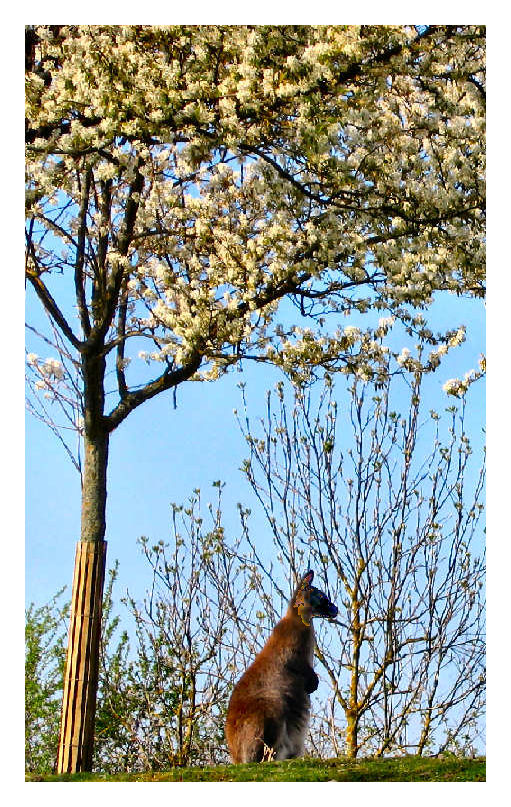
[26,26,485,771]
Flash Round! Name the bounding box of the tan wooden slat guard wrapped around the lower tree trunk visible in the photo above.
[57,541,106,773]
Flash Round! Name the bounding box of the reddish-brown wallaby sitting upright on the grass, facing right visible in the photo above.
[225,571,337,763]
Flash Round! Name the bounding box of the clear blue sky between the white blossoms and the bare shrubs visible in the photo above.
[25,296,485,604]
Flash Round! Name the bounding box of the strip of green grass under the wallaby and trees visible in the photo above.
[26,756,486,782]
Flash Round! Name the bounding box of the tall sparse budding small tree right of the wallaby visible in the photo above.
[240,374,485,757]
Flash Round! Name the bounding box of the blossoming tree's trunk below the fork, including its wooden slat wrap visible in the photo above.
[57,432,108,773]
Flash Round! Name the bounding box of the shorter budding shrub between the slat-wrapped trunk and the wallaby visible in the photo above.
[94,490,270,772]
